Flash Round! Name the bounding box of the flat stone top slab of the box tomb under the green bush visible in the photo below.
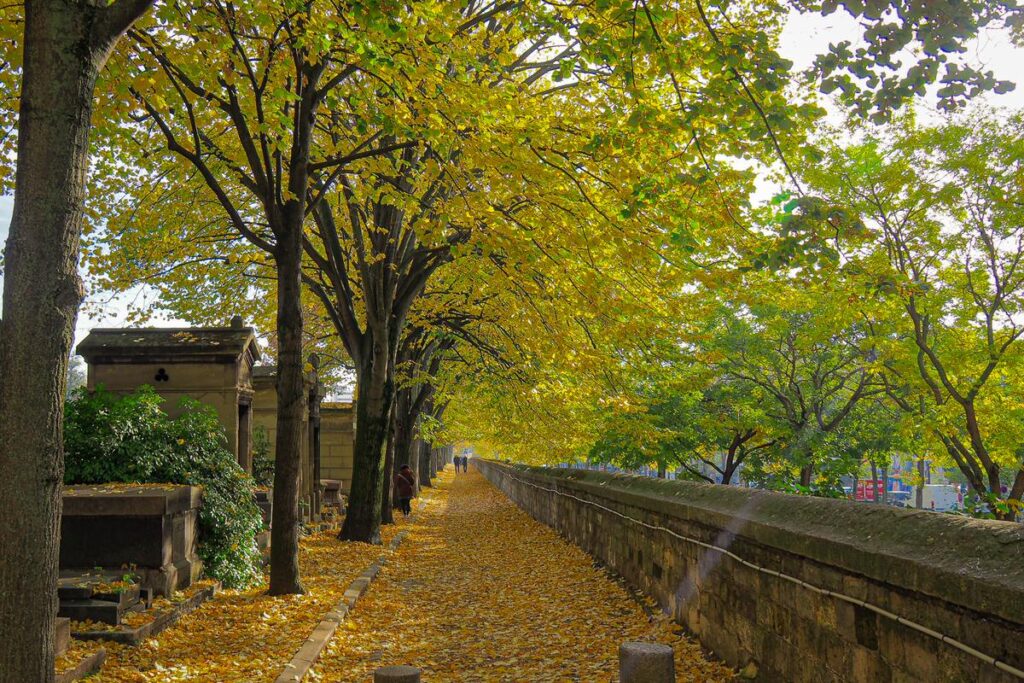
[63,484,203,517]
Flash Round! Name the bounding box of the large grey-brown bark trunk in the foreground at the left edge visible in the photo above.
[0,0,150,682]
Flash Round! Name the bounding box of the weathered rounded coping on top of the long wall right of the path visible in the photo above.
[481,461,1024,625]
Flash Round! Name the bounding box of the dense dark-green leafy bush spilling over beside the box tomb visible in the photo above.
[65,386,262,588]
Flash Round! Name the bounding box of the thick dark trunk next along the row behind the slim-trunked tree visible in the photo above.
[338,330,394,544]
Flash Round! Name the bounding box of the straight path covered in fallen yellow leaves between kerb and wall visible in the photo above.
[314,471,732,683]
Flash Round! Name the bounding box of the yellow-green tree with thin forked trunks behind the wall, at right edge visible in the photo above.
[809,112,1024,519]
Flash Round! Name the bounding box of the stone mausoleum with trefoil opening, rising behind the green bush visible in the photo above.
[77,316,260,472]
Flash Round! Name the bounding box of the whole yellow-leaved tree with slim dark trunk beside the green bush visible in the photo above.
[98,2,440,594]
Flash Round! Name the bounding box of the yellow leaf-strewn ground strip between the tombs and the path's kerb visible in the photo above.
[95,516,401,683]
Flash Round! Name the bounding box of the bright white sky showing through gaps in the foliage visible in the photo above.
[0,11,1024,350]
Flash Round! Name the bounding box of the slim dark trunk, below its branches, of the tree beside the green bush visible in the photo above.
[267,222,306,595]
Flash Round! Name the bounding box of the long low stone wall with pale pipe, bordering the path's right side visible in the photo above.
[474,459,1024,683]
